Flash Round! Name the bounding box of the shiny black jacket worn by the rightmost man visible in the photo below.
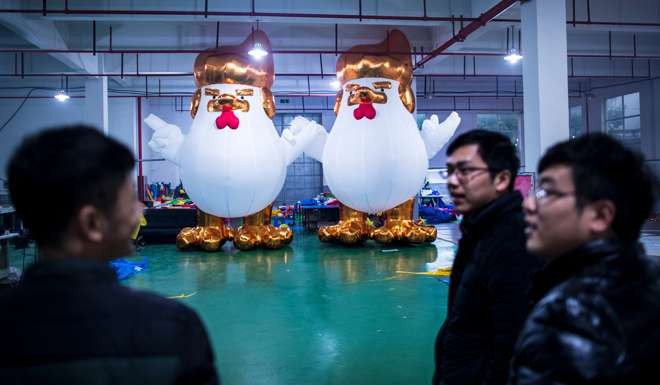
[509,240,660,385]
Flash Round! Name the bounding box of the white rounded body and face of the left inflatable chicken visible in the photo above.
[174,84,286,218]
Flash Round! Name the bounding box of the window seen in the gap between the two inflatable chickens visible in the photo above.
[273,113,323,205]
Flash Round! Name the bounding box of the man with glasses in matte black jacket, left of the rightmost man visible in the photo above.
[433,130,540,385]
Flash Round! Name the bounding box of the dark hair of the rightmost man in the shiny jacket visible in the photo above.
[539,133,657,241]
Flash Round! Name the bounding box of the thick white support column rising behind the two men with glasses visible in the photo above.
[520,0,569,172]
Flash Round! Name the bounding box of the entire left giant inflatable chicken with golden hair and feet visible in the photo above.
[145,30,322,251]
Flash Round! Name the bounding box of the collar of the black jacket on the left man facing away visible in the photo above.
[23,259,117,284]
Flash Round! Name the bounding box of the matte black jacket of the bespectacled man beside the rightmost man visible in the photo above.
[433,192,542,385]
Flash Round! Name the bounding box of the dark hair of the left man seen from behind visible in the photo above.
[7,125,135,245]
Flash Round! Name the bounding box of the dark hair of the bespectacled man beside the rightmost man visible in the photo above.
[447,129,520,191]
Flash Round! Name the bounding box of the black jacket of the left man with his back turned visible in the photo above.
[0,260,219,385]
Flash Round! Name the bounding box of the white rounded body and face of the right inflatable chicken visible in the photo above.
[323,78,428,214]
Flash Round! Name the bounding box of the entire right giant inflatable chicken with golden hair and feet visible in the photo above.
[292,30,460,244]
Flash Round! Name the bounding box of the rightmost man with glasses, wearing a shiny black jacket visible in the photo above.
[509,134,660,385]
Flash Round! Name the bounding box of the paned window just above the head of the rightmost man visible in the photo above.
[605,92,641,149]
